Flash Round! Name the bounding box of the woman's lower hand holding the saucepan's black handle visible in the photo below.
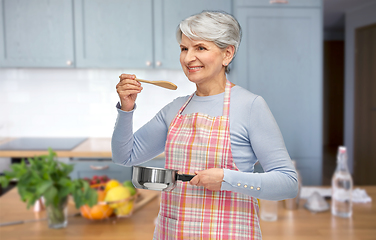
[190,168,224,191]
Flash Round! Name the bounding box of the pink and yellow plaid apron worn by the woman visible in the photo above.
[154,81,261,239]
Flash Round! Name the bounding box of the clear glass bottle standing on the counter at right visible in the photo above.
[332,146,353,218]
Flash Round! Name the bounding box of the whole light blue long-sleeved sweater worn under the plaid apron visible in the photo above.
[112,86,298,200]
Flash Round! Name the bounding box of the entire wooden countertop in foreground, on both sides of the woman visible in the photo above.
[0,186,376,240]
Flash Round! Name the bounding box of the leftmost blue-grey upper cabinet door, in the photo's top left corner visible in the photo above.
[0,0,74,68]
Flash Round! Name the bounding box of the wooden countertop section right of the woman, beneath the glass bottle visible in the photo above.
[260,186,376,240]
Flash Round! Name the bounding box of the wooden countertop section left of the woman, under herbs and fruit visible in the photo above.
[0,188,160,240]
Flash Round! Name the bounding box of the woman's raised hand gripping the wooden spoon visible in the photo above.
[116,74,142,111]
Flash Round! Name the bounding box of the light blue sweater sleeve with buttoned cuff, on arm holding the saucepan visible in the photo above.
[222,96,298,200]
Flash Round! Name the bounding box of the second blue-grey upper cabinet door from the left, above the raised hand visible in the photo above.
[74,0,153,68]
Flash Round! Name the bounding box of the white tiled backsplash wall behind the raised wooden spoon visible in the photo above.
[0,69,195,139]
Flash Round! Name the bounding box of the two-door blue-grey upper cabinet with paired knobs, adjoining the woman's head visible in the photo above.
[74,0,232,69]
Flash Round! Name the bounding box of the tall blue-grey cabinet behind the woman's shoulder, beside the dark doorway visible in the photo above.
[230,0,323,185]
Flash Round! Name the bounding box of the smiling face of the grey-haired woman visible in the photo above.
[180,34,228,84]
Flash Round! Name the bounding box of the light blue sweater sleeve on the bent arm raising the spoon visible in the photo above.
[111,103,168,166]
